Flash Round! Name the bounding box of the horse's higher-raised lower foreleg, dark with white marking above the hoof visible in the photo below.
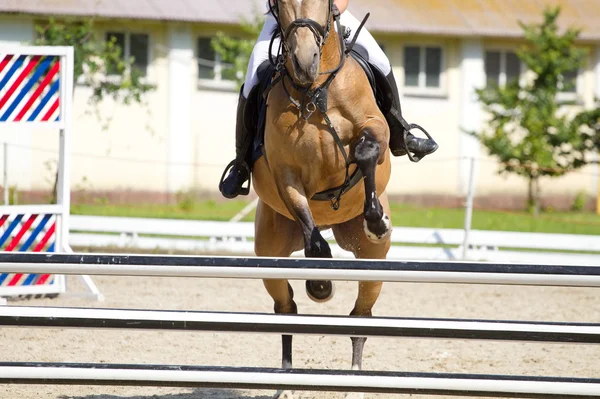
[353,129,392,243]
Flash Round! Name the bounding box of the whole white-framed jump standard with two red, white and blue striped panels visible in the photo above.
[0,45,101,298]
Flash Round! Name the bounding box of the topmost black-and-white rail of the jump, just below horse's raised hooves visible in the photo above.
[0,253,600,287]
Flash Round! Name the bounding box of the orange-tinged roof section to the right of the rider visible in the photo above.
[350,0,600,39]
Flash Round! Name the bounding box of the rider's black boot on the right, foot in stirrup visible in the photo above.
[385,72,438,162]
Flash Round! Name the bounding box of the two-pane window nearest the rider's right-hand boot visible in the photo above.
[404,46,442,89]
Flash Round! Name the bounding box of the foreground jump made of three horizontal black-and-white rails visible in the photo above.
[0,253,600,399]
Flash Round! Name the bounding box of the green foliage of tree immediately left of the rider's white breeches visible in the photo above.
[211,11,265,89]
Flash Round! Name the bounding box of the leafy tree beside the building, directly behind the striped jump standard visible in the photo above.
[34,18,154,202]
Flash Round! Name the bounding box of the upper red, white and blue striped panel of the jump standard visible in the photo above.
[0,53,62,123]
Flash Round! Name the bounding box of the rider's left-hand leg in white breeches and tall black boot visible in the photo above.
[219,14,278,198]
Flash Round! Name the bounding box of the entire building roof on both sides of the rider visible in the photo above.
[0,0,600,40]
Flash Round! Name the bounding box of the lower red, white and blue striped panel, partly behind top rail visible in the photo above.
[0,214,56,296]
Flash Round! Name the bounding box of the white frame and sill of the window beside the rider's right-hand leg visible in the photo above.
[402,42,448,97]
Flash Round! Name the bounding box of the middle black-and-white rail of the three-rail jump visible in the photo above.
[0,306,600,344]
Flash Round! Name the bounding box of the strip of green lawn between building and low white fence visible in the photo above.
[71,200,600,235]
